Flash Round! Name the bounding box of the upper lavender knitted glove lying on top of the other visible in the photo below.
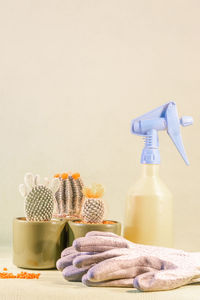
[73,232,200,291]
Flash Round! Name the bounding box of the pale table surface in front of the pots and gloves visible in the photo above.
[0,247,200,300]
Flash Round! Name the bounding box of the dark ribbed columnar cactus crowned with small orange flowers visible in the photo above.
[53,173,84,217]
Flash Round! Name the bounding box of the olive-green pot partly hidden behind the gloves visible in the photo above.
[67,220,121,246]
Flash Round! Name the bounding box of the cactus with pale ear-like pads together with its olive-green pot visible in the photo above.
[13,173,66,269]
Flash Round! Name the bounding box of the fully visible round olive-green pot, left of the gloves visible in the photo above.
[13,217,67,269]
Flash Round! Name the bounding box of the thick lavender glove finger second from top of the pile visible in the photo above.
[73,236,128,252]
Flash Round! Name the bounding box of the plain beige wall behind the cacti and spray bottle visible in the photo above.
[0,0,200,250]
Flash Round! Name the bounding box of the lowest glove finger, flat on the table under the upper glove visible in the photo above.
[82,274,133,288]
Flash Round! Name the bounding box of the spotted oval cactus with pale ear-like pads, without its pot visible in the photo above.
[19,173,60,221]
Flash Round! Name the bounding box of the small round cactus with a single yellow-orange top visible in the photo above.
[82,184,105,223]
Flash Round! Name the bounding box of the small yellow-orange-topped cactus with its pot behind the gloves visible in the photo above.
[68,184,121,246]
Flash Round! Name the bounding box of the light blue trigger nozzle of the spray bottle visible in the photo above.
[131,102,193,165]
